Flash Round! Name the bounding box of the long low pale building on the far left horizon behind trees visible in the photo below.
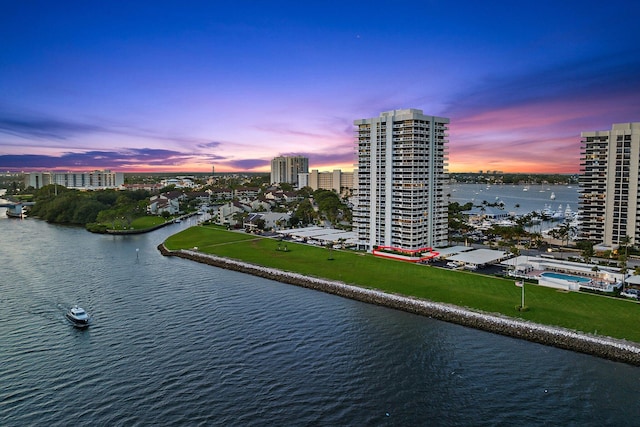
[25,170,124,190]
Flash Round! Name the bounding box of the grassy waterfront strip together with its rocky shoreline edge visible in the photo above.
[158,226,640,366]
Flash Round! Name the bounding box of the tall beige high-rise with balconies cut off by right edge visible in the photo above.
[579,123,640,249]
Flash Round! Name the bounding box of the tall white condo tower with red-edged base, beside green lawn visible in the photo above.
[353,109,449,251]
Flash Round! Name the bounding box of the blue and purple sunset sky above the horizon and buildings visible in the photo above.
[0,0,640,173]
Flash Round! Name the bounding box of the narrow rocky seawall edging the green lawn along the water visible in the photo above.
[158,244,640,366]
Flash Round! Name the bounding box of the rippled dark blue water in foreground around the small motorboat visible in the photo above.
[0,209,640,426]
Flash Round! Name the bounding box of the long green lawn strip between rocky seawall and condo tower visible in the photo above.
[165,226,640,342]
